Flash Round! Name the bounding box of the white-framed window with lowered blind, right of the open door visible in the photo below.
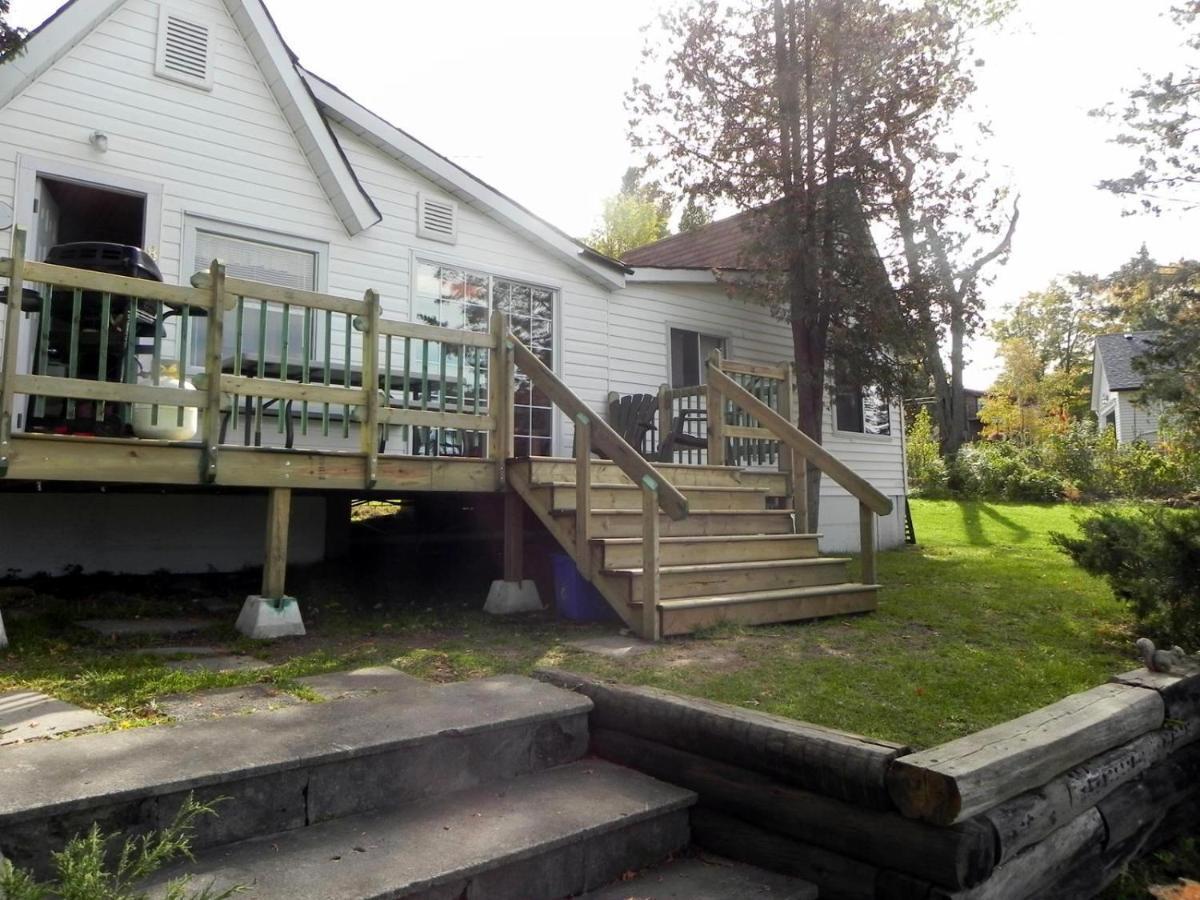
[186,220,325,362]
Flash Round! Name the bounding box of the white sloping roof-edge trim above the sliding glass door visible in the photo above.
[304,69,628,289]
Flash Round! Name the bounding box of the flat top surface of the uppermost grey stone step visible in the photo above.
[0,676,592,826]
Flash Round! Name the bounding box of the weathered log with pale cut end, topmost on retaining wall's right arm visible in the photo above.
[888,684,1165,824]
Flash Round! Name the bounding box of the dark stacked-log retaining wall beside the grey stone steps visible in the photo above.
[538,670,1200,900]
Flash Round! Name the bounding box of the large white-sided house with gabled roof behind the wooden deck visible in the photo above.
[0,0,904,571]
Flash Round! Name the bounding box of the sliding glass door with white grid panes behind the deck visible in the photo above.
[413,262,554,456]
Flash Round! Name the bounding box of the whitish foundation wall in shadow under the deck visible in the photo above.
[0,492,326,577]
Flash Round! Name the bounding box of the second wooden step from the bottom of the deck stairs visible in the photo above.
[605,557,850,600]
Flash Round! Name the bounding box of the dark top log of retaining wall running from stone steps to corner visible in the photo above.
[535,670,905,809]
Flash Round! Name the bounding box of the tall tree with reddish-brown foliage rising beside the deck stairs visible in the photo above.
[629,0,1003,527]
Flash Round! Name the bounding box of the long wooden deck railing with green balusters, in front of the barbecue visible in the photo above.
[0,230,505,487]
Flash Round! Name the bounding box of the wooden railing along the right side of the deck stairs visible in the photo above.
[707,350,892,584]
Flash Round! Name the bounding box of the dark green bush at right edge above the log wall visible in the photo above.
[1051,508,1200,649]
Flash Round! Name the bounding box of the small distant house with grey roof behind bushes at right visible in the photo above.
[1092,331,1163,444]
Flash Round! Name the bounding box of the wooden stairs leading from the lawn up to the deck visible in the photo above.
[506,458,878,636]
